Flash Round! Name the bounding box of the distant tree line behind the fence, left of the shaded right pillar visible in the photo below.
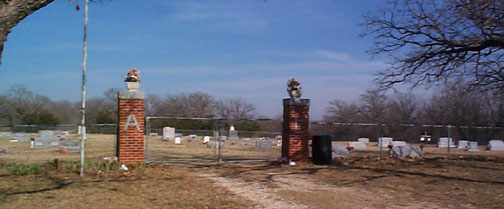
[0,86,257,129]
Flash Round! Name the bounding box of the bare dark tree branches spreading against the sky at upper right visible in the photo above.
[362,0,504,92]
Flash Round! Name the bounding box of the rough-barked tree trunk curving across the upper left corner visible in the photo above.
[0,0,54,64]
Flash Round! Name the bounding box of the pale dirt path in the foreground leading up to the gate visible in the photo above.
[198,170,441,209]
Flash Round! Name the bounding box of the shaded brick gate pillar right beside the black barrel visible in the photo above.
[282,99,310,162]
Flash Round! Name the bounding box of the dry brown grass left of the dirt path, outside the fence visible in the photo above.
[0,165,253,208]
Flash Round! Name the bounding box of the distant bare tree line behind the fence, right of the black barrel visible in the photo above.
[324,81,504,140]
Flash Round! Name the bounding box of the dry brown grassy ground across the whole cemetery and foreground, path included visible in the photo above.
[0,135,504,208]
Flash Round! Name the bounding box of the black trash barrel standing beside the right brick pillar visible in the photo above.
[312,135,332,165]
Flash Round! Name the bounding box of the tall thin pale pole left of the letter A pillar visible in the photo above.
[80,0,88,176]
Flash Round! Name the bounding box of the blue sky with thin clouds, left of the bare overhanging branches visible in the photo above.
[0,0,387,119]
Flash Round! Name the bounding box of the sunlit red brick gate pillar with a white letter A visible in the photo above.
[117,91,144,164]
